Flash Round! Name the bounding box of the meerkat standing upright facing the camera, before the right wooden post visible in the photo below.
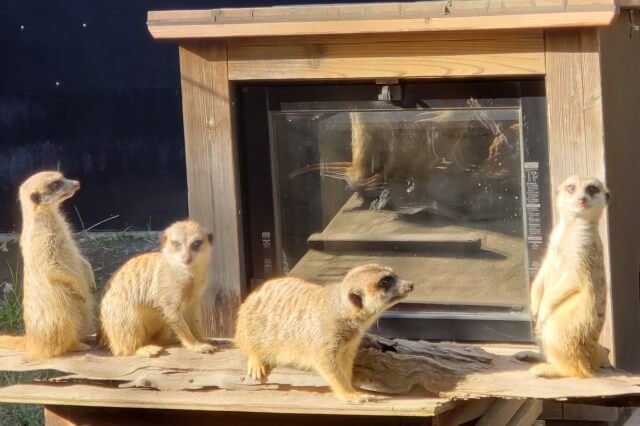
[516,176,610,378]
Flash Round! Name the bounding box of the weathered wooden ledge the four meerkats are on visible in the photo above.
[0,336,640,424]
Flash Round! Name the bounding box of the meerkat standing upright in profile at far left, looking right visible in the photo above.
[0,171,95,360]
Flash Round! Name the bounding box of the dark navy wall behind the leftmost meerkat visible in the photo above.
[0,0,376,232]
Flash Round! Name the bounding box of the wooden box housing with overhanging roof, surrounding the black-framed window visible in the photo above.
[148,0,640,370]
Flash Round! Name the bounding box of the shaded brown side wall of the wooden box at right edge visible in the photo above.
[598,10,640,371]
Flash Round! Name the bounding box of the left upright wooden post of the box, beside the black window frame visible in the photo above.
[180,42,243,336]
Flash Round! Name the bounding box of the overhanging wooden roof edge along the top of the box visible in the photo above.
[147,0,618,39]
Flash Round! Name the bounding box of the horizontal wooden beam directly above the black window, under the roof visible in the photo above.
[229,32,544,80]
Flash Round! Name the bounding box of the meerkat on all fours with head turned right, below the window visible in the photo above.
[235,264,413,403]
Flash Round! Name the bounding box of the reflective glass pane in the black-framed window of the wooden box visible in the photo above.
[270,105,527,306]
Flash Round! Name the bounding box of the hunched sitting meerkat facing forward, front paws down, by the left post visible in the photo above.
[100,220,214,356]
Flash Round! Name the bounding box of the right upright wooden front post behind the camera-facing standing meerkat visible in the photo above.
[545,29,618,357]
